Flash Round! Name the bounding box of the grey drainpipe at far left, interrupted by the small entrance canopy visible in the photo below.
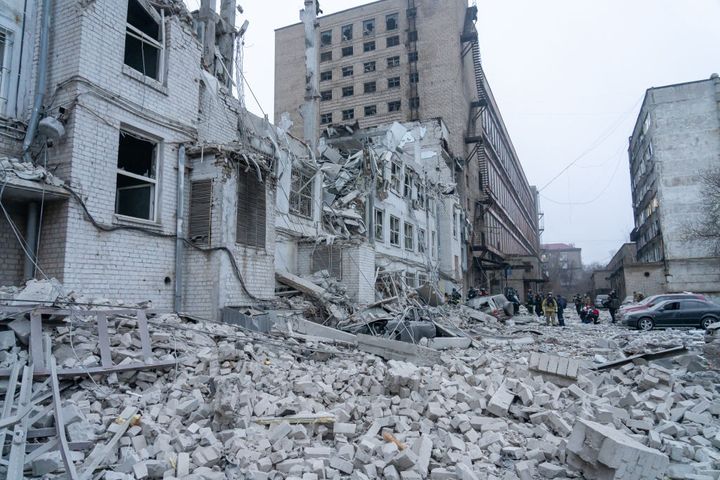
[23,0,51,280]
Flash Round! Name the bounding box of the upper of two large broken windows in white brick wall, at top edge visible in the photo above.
[125,0,165,82]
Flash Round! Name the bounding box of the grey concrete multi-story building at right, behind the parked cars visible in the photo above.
[628,75,720,295]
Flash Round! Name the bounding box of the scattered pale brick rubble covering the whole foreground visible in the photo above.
[0,286,720,480]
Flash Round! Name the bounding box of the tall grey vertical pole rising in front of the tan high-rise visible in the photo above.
[300,0,320,153]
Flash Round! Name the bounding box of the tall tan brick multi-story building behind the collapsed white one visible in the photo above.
[275,0,541,298]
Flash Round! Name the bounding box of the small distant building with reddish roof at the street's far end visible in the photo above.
[540,243,583,295]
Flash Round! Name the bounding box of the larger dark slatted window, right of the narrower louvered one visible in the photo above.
[235,169,266,248]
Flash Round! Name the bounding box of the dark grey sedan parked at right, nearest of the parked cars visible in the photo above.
[623,298,720,330]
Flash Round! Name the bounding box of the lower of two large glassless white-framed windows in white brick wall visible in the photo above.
[115,130,157,221]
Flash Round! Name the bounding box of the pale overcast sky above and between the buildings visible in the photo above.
[186,0,720,264]
